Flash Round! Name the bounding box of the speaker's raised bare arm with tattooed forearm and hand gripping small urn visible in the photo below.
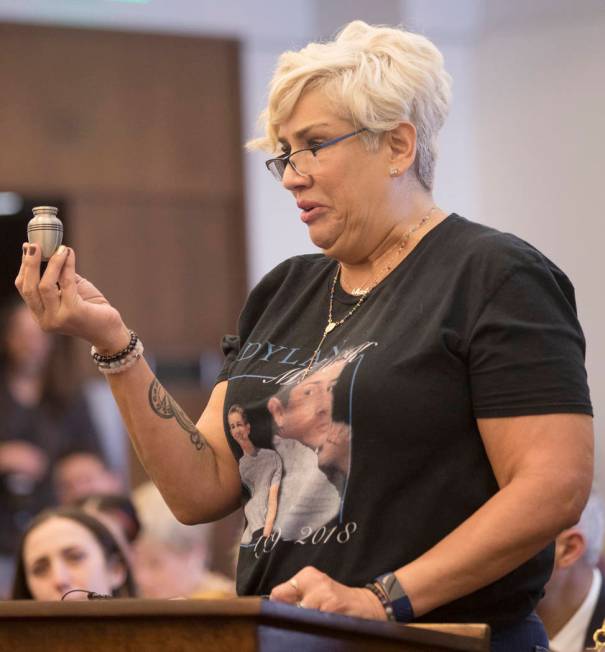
[15,245,240,523]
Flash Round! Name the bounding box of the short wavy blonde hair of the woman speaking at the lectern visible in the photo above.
[247,20,451,190]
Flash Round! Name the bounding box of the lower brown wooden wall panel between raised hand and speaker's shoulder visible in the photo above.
[70,195,242,358]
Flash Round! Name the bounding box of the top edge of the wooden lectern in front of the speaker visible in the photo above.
[0,597,489,652]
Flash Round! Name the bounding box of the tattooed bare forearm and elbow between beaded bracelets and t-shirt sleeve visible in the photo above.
[108,360,241,524]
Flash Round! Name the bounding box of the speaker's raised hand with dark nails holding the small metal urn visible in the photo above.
[15,243,130,352]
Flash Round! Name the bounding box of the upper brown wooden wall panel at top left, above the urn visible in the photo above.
[0,24,241,196]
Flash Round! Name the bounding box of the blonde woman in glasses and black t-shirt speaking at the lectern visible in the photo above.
[17,21,593,652]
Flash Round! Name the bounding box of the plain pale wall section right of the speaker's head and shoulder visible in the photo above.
[473,1,605,494]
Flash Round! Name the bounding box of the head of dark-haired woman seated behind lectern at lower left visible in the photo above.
[11,507,136,600]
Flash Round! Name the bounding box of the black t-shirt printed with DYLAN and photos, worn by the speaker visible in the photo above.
[219,215,591,624]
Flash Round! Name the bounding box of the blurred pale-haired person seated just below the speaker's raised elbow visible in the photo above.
[132,482,235,599]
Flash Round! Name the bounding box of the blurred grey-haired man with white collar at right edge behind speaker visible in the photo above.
[537,491,605,652]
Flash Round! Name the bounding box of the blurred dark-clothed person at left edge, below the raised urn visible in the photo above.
[0,299,99,595]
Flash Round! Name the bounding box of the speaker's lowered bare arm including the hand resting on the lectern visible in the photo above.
[271,414,594,618]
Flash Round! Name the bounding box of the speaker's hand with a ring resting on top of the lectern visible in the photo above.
[270,566,386,620]
